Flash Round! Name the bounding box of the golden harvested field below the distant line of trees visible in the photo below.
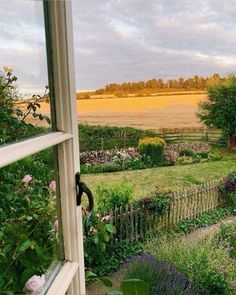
[21,92,206,129]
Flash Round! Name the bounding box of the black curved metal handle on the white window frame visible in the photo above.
[75,172,94,236]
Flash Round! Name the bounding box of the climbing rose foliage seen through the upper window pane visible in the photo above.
[0,68,50,144]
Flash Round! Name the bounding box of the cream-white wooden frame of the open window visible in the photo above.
[0,0,86,295]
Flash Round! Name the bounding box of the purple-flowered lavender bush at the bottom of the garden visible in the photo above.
[122,254,197,295]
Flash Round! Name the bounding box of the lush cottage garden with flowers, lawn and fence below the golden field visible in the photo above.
[0,70,236,295]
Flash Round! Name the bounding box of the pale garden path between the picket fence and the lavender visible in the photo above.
[87,216,236,295]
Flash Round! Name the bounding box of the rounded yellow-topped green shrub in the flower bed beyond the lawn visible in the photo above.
[138,137,165,165]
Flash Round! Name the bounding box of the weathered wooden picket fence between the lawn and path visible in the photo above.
[109,178,224,242]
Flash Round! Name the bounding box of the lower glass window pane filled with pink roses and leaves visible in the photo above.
[0,148,63,294]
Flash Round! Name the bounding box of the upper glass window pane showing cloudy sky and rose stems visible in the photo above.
[0,0,51,145]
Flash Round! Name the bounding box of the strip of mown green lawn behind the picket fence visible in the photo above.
[82,157,236,204]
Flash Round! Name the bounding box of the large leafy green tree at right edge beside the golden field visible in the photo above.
[198,76,236,135]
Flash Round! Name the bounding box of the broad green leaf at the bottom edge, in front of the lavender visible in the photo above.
[121,279,149,295]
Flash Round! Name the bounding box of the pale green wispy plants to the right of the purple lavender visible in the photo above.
[154,239,236,295]
